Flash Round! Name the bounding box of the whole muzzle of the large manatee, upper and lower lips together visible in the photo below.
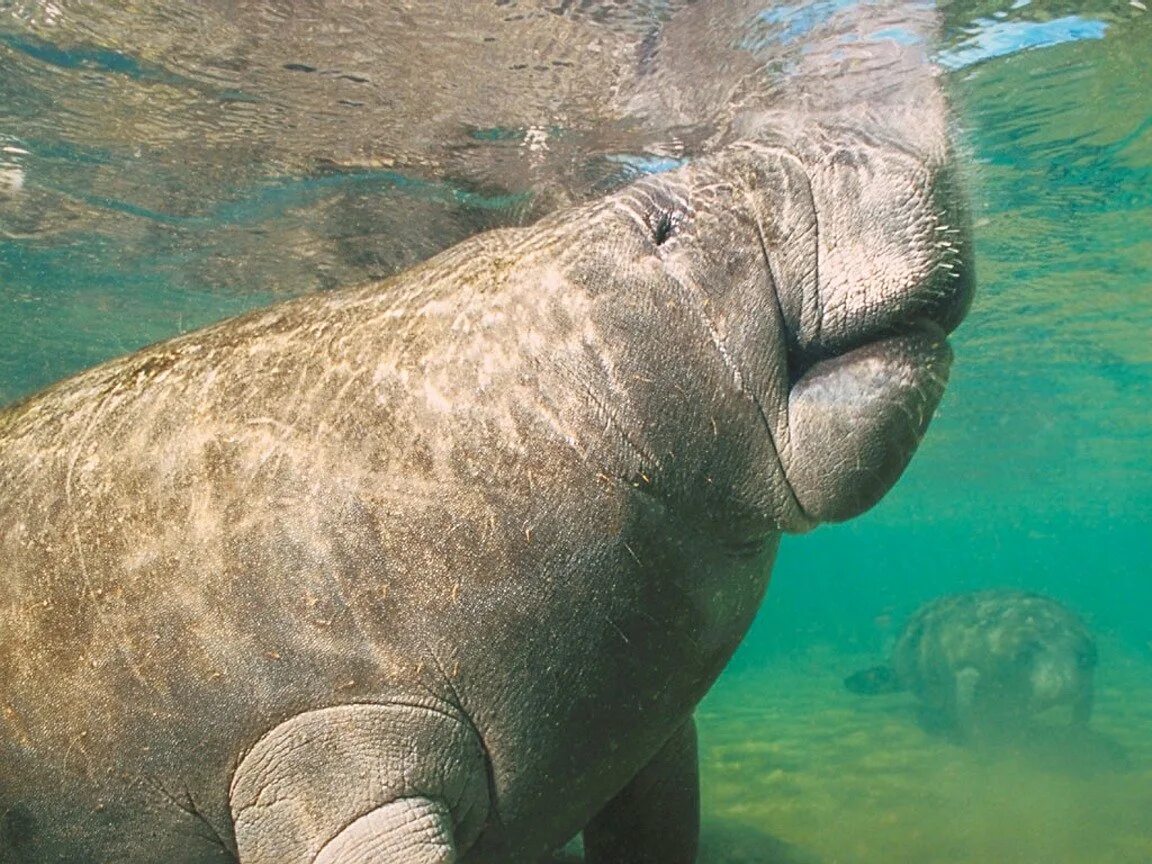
[779,130,973,523]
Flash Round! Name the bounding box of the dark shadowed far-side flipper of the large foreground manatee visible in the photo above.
[584,719,700,864]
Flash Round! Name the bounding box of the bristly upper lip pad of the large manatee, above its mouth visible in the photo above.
[782,130,975,369]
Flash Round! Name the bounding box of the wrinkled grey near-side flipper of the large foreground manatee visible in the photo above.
[229,703,488,864]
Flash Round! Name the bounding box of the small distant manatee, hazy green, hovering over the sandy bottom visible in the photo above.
[844,590,1097,736]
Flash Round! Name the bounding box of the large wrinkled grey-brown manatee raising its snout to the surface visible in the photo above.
[0,3,972,864]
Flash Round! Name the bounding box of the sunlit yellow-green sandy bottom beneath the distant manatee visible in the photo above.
[697,646,1152,864]
